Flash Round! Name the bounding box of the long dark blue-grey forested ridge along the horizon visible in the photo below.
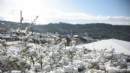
[0,21,130,41]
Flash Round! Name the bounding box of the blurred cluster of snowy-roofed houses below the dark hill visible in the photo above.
[0,32,96,44]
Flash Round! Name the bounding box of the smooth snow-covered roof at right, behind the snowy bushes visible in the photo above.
[77,39,130,55]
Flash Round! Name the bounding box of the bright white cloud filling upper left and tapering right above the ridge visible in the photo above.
[0,0,130,25]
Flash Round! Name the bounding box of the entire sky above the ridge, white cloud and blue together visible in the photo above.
[0,0,130,25]
